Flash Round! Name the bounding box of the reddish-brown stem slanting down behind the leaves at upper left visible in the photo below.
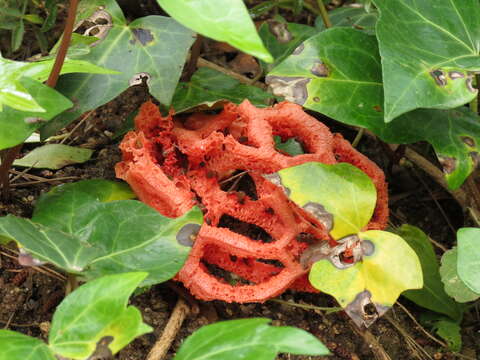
[0,0,78,200]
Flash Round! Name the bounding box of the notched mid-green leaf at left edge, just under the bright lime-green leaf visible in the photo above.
[0,77,73,150]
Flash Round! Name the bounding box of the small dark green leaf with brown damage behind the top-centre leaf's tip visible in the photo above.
[258,22,317,71]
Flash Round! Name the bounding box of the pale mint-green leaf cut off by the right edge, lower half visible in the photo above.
[457,228,480,296]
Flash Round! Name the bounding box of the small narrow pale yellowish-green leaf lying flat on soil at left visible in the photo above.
[13,144,93,170]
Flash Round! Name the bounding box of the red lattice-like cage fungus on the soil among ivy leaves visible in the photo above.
[116,100,388,302]
